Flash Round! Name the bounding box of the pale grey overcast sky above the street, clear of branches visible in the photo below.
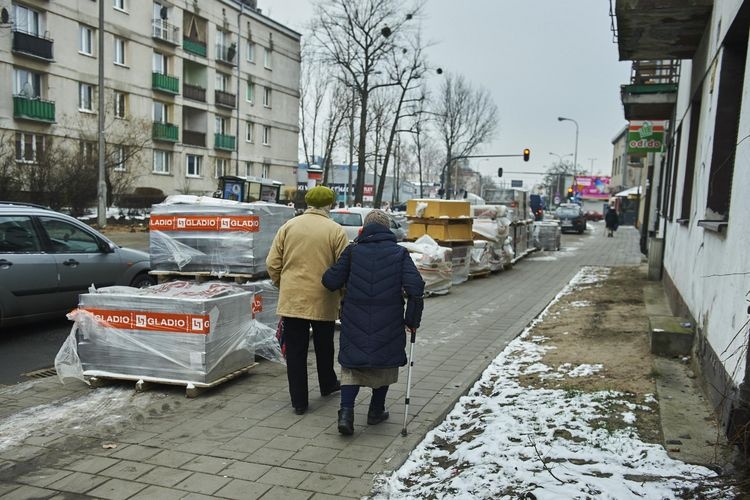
[258,0,630,187]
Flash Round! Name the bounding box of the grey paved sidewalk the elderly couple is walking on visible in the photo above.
[0,224,656,499]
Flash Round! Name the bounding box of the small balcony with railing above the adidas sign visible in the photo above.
[620,60,680,120]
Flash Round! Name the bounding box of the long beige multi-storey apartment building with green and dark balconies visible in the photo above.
[0,0,301,203]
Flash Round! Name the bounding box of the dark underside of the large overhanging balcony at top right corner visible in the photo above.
[613,0,714,61]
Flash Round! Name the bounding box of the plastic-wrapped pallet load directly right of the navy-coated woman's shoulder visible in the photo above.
[399,235,453,295]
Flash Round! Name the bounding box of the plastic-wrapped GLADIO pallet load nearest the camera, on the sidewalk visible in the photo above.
[55,281,283,385]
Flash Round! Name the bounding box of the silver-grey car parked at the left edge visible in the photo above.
[0,201,156,326]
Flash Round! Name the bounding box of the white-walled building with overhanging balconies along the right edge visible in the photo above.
[616,0,750,446]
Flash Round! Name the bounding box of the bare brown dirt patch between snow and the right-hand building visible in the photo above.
[519,267,662,443]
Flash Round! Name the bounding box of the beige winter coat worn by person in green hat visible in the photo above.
[266,208,349,321]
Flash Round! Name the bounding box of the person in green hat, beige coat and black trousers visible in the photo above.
[266,186,349,415]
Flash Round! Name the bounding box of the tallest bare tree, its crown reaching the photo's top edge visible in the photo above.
[313,0,419,203]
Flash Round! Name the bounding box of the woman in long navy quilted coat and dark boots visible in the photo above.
[322,210,424,436]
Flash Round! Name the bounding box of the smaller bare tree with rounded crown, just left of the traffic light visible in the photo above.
[432,74,498,198]
